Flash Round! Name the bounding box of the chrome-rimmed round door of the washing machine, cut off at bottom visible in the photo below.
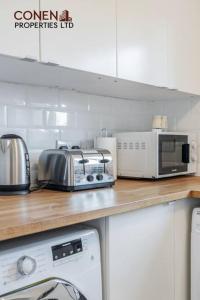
[0,278,88,300]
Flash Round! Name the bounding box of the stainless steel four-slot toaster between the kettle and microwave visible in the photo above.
[38,149,114,191]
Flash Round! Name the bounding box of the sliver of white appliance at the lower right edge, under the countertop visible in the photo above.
[191,208,200,300]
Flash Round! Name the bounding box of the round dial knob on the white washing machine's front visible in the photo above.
[17,256,36,276]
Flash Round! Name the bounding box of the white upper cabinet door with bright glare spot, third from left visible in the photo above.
[117,0,167,86]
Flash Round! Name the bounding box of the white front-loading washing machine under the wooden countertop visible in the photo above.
[0,227,102,300]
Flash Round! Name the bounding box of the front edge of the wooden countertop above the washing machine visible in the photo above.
[0,190,193,242]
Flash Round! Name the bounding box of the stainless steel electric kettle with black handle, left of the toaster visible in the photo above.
[0,134,30,195]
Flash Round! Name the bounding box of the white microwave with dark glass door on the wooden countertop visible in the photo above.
[115,130,197,179]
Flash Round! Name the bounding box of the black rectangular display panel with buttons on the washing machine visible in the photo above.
[51,239,83,261]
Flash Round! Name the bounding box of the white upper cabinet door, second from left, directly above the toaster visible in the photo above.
[41,0,116,76]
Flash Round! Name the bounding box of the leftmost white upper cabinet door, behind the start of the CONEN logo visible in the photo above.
[0,0,39,59]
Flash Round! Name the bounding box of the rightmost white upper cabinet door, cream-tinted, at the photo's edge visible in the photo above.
[168,0,200,95]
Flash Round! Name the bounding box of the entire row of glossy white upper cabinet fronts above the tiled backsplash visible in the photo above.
[0,0,200,95]
